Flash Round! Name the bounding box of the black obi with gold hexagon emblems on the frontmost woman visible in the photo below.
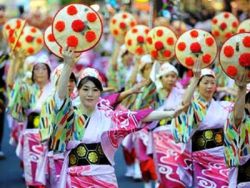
[69,143,111,167]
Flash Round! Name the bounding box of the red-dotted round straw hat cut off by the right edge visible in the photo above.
[219,33,250,82]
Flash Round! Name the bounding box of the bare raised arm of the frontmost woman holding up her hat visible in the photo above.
[56,49,75,99]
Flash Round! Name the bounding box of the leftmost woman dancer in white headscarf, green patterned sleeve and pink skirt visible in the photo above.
[8,53,52,187]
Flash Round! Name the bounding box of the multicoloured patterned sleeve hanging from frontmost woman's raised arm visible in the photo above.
[50,94,75,152]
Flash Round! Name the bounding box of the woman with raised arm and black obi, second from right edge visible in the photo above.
[172,63,232,187]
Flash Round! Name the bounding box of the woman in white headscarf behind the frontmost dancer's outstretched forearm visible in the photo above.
[149,62,184,188]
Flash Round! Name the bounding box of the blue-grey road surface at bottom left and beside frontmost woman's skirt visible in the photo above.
[0,119,143,188]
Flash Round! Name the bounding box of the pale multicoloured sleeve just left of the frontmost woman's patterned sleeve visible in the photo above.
[39,96,55,142]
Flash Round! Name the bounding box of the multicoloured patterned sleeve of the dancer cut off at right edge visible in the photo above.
[224,112,250,167]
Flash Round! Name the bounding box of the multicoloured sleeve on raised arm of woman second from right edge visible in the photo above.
[171,98,207,143]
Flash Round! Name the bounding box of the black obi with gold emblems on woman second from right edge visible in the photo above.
[192,128,224,151]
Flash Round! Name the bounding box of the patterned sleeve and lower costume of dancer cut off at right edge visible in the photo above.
[224,111,250,187]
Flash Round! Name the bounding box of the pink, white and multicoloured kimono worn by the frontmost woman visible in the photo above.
[50,95,152,188]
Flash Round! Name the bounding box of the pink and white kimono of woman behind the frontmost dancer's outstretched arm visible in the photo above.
[149,87,184,188]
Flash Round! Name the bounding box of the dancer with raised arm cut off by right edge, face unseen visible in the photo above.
[224,77,250,188]
